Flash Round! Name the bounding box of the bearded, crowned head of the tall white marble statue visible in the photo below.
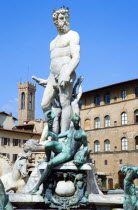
[53,7,70,33]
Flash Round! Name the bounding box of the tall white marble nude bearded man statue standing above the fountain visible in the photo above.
[33,8,80,138]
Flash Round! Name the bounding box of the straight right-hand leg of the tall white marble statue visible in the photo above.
[59,72,76,133]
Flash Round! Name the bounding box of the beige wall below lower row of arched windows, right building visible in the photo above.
[91,151,138,189]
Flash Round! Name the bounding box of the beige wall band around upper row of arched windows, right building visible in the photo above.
[81,98,138,129]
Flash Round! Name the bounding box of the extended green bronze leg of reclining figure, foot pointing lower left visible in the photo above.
[30,152,72,193]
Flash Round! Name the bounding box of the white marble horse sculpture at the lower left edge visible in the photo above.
[0,153,28,192]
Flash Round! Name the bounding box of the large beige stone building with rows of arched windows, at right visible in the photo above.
[81,79,138,190]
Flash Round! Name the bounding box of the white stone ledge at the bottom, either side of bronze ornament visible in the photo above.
[9,193,124,210]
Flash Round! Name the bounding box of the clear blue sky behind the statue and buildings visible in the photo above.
[0,0,138,118]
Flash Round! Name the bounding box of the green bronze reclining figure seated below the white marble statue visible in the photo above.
[24,110,89,194]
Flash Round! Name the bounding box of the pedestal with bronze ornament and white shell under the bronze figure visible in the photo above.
[22,161,102,210]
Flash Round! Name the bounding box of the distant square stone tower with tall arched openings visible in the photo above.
[18,82,36,125]
